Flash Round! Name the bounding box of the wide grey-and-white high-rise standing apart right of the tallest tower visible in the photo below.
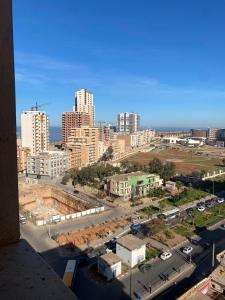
[117,112,140,133]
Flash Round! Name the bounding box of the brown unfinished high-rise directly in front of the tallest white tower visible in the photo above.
[62,112,91,145]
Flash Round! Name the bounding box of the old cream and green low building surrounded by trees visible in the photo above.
[105,172,163,200]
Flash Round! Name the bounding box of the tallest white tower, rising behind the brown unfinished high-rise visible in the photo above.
[74,89,95,127]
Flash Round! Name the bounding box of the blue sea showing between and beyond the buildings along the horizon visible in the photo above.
[16,126,197,143]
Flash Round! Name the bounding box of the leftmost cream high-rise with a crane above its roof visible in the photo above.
[21,111,49,154]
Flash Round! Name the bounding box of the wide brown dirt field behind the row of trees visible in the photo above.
[127,149,221,173]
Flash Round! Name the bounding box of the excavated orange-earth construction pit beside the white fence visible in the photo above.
[19,183,94,221]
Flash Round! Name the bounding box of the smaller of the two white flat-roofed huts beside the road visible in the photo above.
[98,252,122,280]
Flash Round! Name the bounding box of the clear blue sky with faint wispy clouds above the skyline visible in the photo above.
[14,0,225,127]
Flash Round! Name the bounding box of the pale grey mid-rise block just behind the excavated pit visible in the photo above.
[27,151,69,179]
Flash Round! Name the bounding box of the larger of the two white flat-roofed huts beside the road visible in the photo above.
[116,234,146,268]
